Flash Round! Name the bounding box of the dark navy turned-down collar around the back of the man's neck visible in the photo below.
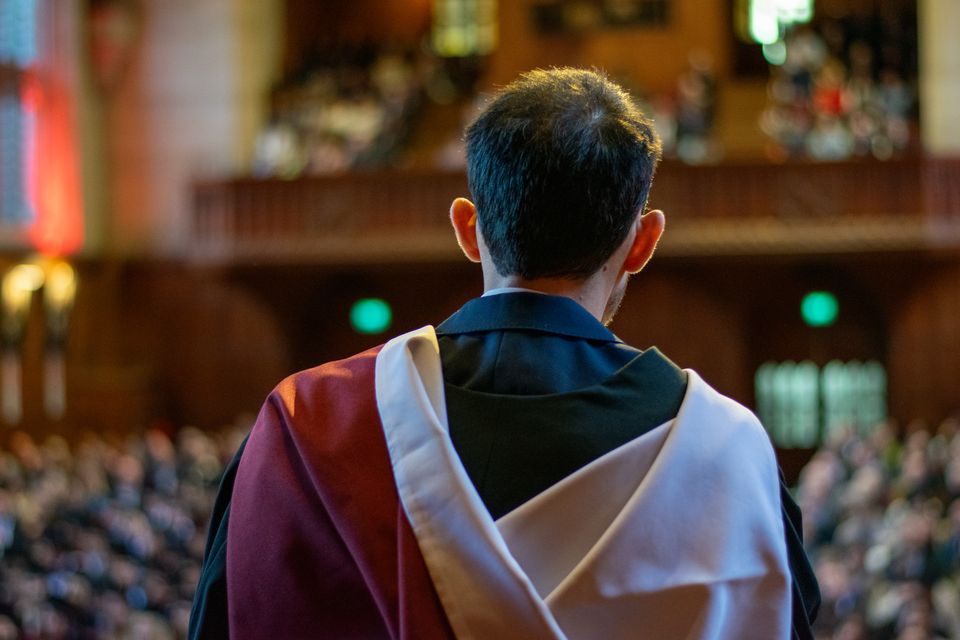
[437,291,620,342]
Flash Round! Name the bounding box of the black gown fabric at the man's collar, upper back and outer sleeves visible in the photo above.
[188,292,820,640]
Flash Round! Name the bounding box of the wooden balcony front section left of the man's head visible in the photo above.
[191,172,468,264]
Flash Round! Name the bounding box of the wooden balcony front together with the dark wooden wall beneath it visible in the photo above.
[15,159,960,450]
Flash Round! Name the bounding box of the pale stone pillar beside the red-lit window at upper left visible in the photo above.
[108,0,283,256]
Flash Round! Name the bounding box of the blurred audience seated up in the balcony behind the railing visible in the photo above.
[246,10,917,178]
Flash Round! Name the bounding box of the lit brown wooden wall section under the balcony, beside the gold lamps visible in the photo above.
[54,261,293,435]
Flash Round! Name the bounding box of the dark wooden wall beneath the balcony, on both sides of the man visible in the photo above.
[50,245,960,440]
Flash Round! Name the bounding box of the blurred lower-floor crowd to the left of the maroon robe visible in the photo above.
[0,425,249,640]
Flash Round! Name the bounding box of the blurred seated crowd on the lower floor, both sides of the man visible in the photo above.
[0,410,960,640]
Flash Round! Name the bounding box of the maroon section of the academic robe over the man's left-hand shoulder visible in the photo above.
[227,349,453,640]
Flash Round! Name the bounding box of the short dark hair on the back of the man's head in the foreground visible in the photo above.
[466,68,660,279]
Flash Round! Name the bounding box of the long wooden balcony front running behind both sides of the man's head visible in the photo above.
[191,158,960,264]
